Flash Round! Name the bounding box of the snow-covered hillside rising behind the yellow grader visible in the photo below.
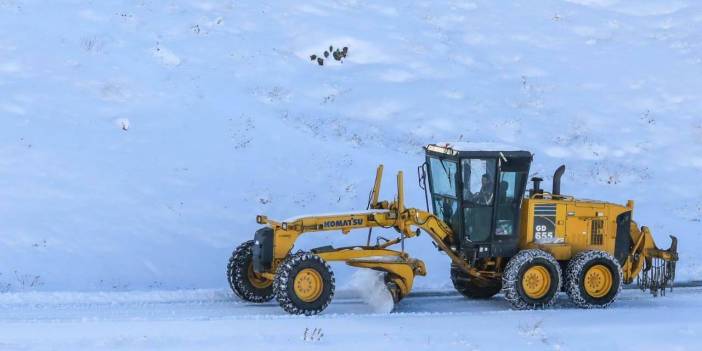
[0,0,702,291]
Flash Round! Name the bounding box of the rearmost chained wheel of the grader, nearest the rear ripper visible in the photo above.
[566,250,622,308]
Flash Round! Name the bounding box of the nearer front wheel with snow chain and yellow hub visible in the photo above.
[273,252,334,316]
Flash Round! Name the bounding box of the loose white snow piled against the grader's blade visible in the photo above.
[348,268,395,313]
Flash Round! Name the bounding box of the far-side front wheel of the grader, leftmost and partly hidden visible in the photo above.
[227,240,273,303]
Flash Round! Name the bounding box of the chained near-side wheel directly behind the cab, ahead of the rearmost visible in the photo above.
[502,249,561,310]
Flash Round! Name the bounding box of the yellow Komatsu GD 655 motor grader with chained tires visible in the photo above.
[227,143,678,315]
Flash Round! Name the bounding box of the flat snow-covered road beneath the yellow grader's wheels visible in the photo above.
[0,287,702,351]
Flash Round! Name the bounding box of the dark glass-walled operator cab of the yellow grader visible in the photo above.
[420,145,532,259]
